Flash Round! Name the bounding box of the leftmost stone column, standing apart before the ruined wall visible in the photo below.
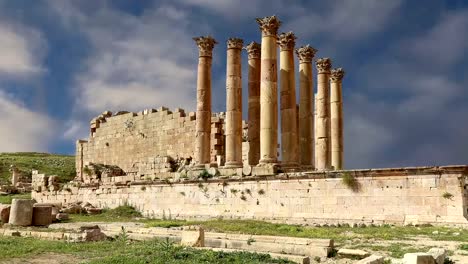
[193,36,217,167]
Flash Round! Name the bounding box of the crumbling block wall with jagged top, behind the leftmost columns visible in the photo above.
[76,107,224,179]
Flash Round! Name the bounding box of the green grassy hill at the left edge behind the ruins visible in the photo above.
[0,152,76,183]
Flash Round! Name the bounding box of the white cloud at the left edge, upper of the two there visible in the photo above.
[0,21,46,79]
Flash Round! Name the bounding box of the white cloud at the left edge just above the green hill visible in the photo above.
[0,91,57,152]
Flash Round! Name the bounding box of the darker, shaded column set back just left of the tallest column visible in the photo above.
[244,42,261,165]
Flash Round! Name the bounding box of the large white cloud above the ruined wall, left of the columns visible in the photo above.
[61,6,202,115]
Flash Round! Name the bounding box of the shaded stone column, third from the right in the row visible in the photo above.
[296,45,317,168]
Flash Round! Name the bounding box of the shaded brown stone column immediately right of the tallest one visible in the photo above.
[278,31,299,166]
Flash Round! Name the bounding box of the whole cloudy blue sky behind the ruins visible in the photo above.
[0,0,468,168]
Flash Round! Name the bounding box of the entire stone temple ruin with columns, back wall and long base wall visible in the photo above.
[32,16,468,225]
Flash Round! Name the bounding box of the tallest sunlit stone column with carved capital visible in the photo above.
[257,16,281,164]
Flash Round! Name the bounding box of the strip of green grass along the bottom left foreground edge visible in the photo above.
[0,236,291,264]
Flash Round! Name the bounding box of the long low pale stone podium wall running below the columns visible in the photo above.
[33,166,468,225]
